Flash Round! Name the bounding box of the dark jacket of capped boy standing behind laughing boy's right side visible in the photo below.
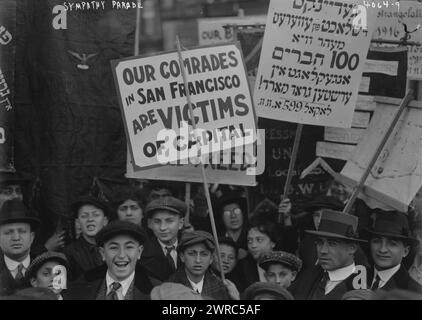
[141,236,180,284]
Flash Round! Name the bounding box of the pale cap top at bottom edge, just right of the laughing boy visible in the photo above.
[151,282,203,300]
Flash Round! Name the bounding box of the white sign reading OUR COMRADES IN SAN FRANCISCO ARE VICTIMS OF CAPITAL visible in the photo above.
[112,44,256,171]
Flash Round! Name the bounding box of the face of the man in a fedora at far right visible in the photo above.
[370,236,410,270]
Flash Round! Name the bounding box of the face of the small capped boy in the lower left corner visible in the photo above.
[31,261,66,294]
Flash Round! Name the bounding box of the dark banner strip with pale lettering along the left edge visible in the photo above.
[0,0,16,171]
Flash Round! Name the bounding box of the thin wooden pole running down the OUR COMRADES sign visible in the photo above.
[176,36,225,281]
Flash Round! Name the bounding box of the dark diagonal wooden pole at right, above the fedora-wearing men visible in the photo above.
[343,90,414,213]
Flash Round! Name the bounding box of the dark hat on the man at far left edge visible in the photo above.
[0,199,40,229]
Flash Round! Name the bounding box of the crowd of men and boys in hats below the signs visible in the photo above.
[0,174,422,300]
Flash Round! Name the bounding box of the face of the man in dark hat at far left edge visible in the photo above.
[0,222,34,261]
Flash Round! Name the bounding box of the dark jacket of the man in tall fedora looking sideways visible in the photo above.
[289,266,362,300]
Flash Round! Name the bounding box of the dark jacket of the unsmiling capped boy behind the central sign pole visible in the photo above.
[168,267,230,300]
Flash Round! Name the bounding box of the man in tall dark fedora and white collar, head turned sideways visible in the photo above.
[290,210,365,300]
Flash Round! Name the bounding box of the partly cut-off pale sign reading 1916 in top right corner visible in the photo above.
[368,0,422,80]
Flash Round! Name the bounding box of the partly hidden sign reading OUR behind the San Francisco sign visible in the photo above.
[198,16,267,46]
